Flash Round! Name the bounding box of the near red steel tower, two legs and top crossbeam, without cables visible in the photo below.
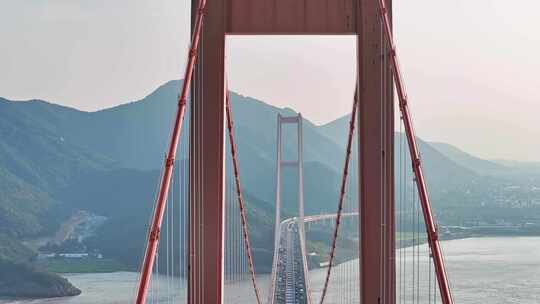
[188,0,395,304]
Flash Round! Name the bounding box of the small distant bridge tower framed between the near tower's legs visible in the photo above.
[268,114,311,304]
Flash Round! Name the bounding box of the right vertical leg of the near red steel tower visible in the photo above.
[357,0,396,304]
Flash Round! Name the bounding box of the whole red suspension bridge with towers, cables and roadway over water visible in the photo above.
[134,0,454,304]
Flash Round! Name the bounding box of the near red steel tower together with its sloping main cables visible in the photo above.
[136,0,453,304]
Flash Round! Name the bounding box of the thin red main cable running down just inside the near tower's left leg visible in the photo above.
[225,86,262,304]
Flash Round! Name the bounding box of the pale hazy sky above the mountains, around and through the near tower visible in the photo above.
[0,0,540,161]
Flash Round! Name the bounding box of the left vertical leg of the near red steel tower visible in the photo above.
[188,0,226,304]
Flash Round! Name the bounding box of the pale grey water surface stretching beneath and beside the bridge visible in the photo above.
[0,237,540,304]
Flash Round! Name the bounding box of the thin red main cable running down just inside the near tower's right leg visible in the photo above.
[319,90,358,304]
